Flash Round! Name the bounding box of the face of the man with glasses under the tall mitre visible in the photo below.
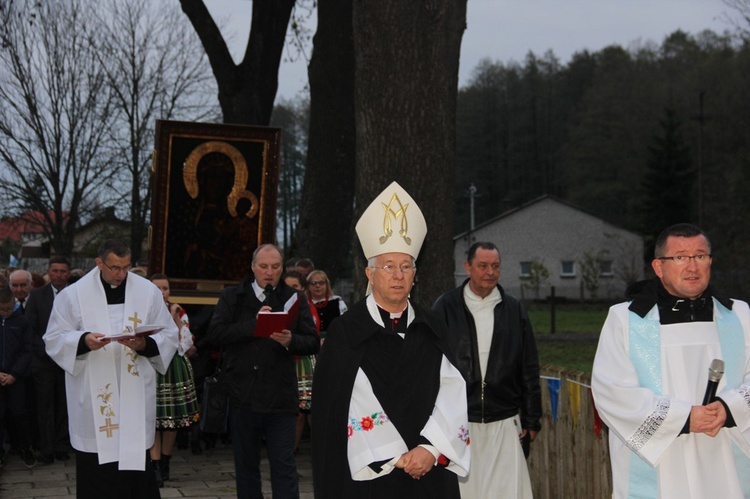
[365,253,417,313]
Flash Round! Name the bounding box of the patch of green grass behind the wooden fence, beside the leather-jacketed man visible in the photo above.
[527,303,609,373]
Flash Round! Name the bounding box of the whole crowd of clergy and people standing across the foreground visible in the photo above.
[0,183,750,499]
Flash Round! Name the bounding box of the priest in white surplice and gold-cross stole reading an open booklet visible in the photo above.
[44,240,177,498]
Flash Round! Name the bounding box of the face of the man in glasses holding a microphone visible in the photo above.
[651,235,711,300]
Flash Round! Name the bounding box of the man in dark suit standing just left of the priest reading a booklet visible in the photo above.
[26,256,70,464]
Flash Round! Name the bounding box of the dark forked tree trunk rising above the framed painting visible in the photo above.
[180,0,295,126]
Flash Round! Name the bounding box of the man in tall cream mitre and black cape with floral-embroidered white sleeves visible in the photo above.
[312,182,469,499]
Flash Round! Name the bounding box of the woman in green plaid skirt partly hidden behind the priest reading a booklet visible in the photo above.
[150,274,198,487]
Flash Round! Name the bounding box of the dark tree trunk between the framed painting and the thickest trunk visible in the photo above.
[295,0,355,282]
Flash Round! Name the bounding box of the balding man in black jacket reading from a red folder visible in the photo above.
[208,244,320,499]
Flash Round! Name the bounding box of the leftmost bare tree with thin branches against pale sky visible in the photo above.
[0,0,114,254]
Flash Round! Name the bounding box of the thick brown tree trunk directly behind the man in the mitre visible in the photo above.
[353,0,466,306]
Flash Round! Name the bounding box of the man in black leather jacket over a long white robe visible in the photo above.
[433,242,542,499]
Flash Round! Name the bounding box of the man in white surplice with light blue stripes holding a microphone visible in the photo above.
[592,224,750,499]
